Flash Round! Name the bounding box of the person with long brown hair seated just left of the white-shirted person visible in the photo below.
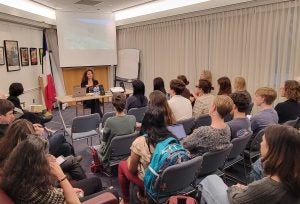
[149,91,176,125]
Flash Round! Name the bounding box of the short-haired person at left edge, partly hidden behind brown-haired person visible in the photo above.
[0,99,75,157]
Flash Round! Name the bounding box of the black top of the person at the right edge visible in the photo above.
[275,99,300,123]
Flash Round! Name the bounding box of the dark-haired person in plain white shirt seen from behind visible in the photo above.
[168,79,192,121]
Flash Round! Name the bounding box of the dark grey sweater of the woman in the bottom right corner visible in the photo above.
[227,177,299,204]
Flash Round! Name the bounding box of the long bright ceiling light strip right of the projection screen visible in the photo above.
[115,0,210,21]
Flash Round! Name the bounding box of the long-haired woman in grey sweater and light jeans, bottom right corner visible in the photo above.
[201,125,300,204]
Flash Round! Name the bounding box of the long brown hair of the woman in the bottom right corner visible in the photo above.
[262,125,300,198]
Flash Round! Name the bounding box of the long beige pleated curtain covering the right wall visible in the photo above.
[117,0,300,107]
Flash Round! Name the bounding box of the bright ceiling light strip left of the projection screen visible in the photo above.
[0,0,56,19]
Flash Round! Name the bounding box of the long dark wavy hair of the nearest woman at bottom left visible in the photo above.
[1,135,53,198]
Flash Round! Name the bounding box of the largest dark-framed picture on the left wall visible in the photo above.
[4,40,21,72]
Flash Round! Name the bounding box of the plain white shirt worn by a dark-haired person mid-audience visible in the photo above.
[168,95,193,121]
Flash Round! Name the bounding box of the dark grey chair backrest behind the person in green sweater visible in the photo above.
[108,132,139,157]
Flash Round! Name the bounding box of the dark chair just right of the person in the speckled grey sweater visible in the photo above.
[223,130,252,182]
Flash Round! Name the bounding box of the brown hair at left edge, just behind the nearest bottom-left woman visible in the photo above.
[0,119,35,167]
